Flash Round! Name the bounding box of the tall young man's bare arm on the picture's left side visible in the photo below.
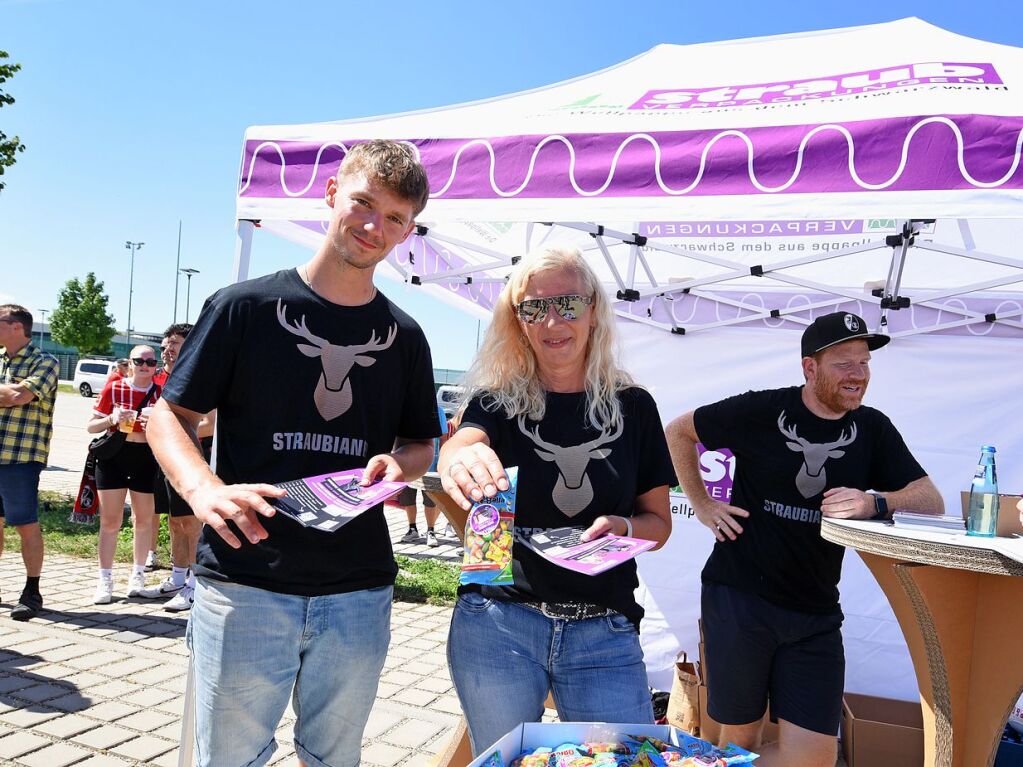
[146,399,284,548]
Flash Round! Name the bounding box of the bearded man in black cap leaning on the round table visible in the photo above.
[666,312,944,767]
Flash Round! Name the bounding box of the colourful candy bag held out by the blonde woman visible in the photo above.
[458,466,519,586]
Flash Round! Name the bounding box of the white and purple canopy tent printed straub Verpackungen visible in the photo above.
[235,18,1023,698]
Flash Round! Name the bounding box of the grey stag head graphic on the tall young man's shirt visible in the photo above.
[277,299,398,420]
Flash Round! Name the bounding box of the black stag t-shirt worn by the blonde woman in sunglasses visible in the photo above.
[460,388,675,624]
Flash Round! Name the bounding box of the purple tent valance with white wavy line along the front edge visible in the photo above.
[239,115,1023,199]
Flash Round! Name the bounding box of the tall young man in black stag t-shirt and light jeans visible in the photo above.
[148,141,440,767]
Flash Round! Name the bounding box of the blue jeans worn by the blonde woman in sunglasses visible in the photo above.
[447,593,654,756]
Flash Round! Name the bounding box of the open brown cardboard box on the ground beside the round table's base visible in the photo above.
[842,692,924,767]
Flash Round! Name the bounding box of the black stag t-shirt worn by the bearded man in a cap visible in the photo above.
[694,387,926,613]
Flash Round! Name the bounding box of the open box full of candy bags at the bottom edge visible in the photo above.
[469,722,756,767]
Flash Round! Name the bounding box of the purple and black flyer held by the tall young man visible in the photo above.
[266,468,407,533]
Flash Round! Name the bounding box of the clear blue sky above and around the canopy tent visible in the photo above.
[0,0,1023,368]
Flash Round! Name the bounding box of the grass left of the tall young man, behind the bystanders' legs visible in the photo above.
[4,490,171,565]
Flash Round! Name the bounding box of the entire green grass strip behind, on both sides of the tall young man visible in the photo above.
[10,490,458,604]
